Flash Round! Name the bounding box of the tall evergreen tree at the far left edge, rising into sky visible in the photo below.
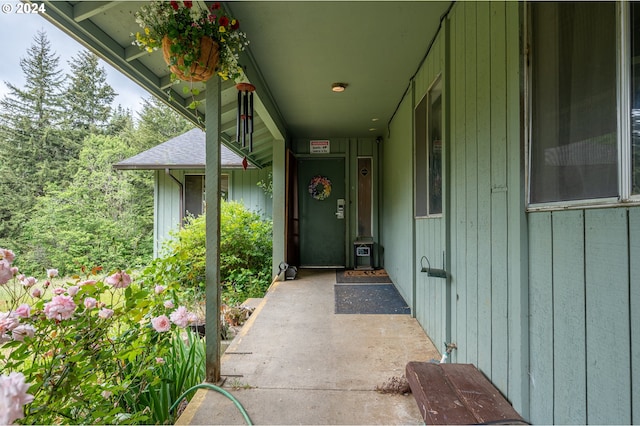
[0,31,68,247]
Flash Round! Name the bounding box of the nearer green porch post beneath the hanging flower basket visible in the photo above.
[205,75,221,383]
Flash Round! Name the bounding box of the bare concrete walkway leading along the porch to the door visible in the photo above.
[176,270,440,425]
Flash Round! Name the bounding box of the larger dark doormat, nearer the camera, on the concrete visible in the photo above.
[333,284,411,314]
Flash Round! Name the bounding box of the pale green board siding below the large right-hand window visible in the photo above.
[528,207,640,424]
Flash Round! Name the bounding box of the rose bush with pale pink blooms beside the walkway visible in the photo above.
[0,248,204,424]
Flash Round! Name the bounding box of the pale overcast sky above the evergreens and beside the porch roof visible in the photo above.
[0,0,151,118]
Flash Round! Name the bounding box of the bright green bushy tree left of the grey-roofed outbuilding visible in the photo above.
[18,135,153,274]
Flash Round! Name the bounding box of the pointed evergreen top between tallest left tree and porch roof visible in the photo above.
[66,50,116,136]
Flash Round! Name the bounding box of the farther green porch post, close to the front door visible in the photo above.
[271,139,287,279]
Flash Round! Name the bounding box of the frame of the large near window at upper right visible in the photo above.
[523,2,640,211]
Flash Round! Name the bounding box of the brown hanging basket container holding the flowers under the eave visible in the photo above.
[162,36,219,81]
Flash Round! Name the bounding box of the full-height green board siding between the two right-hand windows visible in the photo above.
[446,2,529,415]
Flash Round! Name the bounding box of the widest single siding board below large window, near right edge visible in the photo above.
[585,209,631,424]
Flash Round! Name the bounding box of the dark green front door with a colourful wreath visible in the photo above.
[298,158,347,267]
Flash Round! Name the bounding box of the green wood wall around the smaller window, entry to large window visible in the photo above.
[381,2,529,416]
